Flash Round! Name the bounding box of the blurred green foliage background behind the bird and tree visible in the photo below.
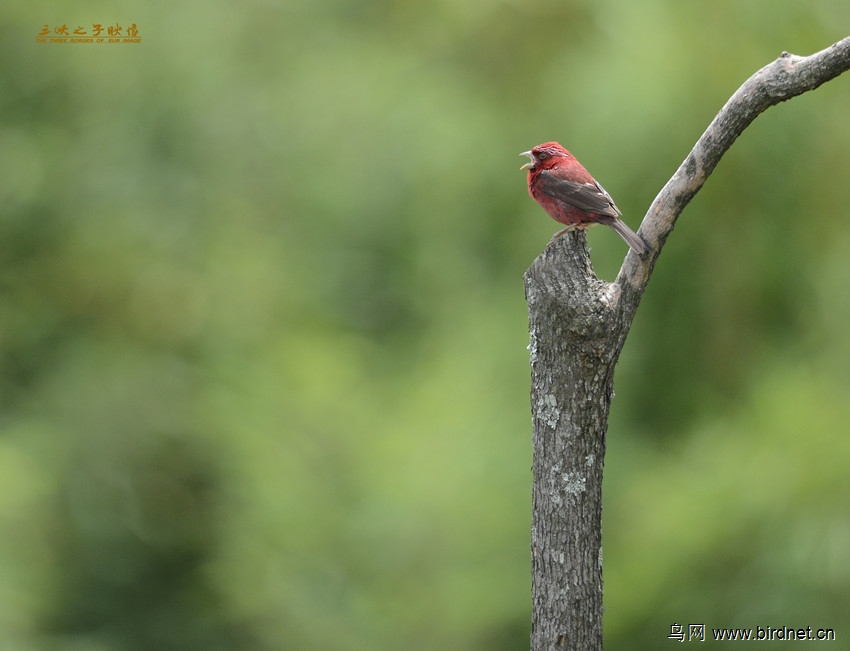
[0,0,850,651]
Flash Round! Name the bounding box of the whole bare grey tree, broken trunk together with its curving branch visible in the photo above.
[524,37,850,651]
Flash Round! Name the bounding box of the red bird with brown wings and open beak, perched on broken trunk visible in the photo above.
[520,142,652,255]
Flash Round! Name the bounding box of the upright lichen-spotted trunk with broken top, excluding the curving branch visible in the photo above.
[525,231,628,649]
